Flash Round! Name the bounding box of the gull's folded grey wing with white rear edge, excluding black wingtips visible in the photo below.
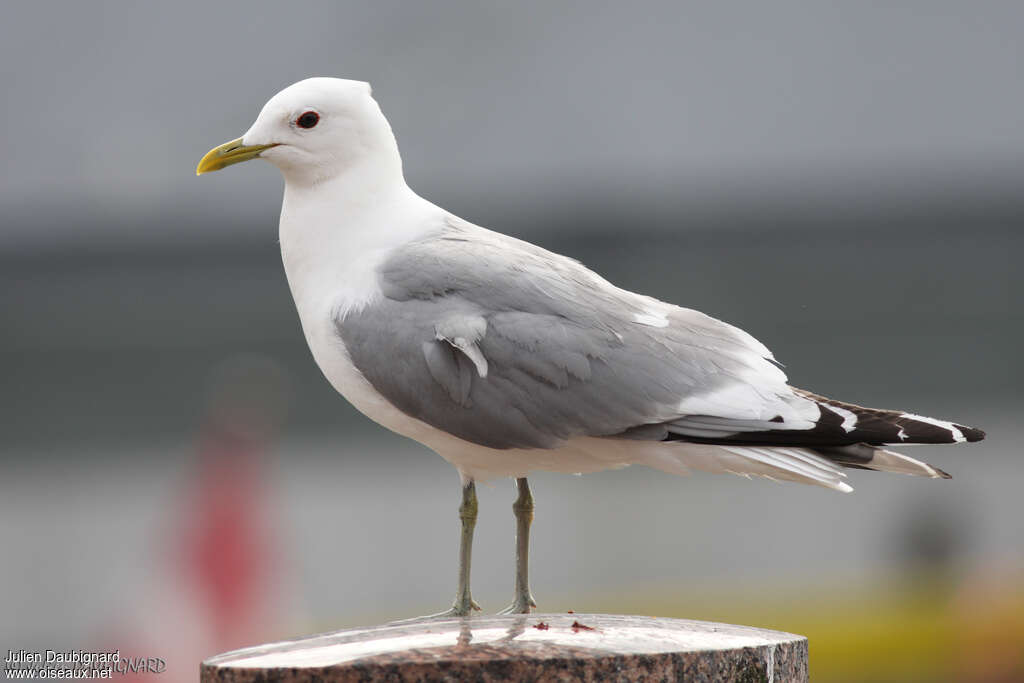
[337,223,816,449]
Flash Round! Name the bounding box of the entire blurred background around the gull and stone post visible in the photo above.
[0,0,1024,681]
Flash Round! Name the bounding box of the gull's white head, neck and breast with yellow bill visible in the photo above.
[197,78,446,382]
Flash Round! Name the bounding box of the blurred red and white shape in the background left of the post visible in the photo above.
[101,356,292,683]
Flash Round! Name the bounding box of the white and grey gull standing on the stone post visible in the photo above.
[197,78,984,616]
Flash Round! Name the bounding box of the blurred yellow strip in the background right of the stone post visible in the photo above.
[589,577,1024,683]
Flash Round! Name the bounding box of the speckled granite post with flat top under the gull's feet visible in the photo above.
[202,614,807,683]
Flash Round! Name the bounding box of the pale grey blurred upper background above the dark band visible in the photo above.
[0,0,1024,248]
